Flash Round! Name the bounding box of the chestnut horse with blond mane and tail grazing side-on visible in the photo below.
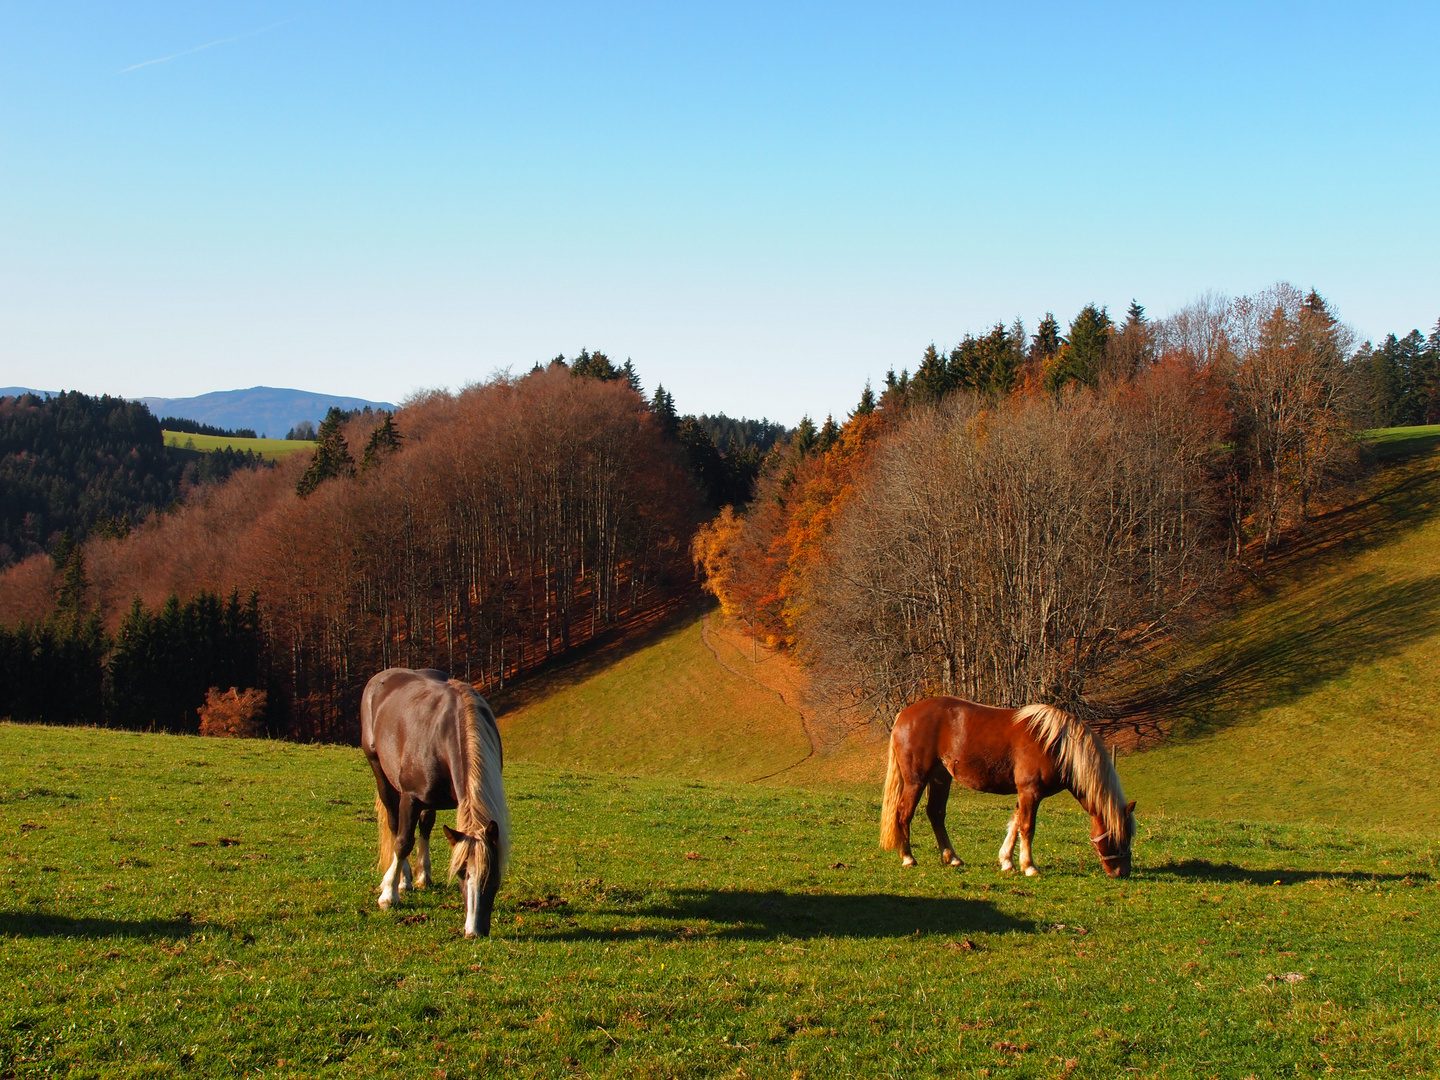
[880,697,1135,877]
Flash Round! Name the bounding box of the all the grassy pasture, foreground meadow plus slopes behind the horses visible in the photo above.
[0,441,1440,1080]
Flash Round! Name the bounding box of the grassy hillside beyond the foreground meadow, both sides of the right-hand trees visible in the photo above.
[501,428,1440,831]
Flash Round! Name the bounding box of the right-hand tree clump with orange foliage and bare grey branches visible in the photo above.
[693,285,1437,720]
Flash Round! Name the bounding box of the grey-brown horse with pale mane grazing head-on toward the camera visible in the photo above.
[360,668,510,937]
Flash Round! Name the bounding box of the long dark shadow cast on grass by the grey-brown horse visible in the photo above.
[524,888,1035,942]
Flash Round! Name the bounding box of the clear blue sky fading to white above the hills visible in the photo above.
[0,0,1440,423]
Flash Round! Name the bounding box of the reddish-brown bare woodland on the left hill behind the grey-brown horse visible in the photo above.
[0,360,720,740]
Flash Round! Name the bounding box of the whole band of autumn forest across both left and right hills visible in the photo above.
[0,296,1440,742]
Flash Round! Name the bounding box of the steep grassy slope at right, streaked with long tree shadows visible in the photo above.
[1120,452,1440,835]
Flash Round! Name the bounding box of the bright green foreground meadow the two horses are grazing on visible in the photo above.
[0,726,1440,1077]
